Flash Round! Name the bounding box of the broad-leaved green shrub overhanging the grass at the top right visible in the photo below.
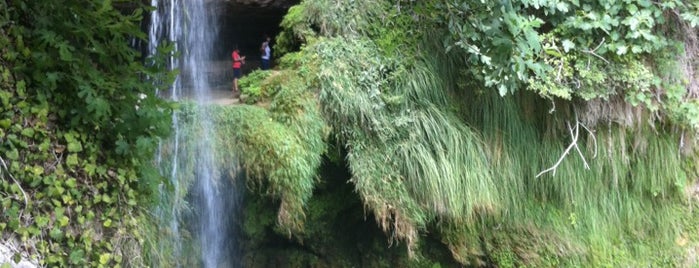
[416,0,699,106]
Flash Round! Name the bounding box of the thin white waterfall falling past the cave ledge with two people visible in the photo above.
[148,0,240,267]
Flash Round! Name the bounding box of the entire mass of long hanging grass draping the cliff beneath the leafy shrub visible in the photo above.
[221,1,697,267]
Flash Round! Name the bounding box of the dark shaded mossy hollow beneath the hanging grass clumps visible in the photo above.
[243,160,458,268]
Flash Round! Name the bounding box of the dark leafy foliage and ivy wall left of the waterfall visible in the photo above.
[0,1,170,267]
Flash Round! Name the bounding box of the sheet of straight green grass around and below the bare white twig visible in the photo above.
[448,88,696,267]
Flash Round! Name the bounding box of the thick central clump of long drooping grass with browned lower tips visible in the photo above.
[315,38,499,253]
